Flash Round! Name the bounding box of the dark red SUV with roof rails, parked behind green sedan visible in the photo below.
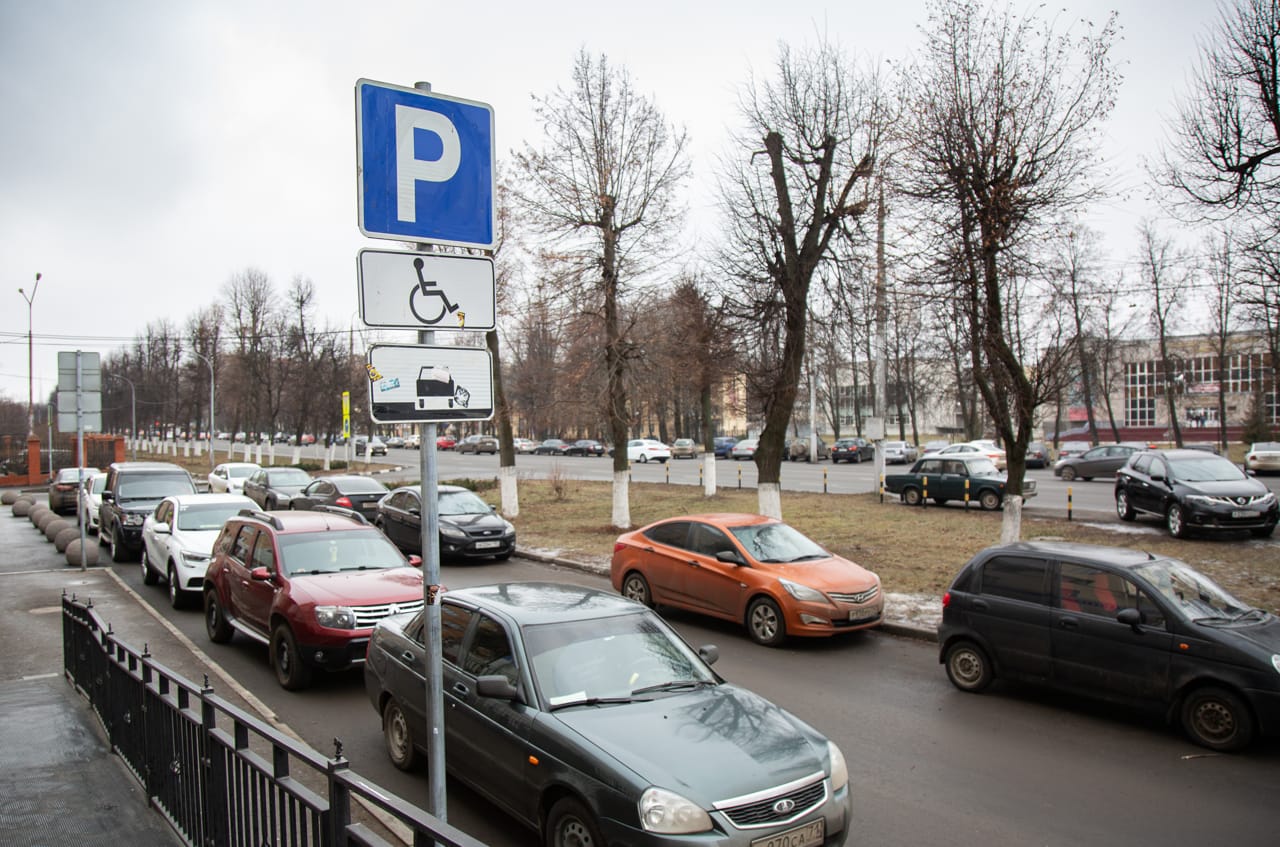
[204,509,422,691]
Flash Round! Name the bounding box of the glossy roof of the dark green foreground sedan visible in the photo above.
[444,582,645,626]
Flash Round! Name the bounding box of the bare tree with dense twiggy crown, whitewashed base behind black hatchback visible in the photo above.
[906,0,1117,537]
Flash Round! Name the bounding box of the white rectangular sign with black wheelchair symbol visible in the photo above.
[366,249,497,330]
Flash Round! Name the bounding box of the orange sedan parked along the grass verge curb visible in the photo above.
[611,514,884,647]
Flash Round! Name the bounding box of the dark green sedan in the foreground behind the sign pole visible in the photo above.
[365,582,852,847]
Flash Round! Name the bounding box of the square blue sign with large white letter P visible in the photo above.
[356,79,494,247]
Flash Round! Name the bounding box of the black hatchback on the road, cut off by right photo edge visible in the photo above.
[938,542,1280,751]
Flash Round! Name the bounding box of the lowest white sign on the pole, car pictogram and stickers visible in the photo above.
[365,344,494,424]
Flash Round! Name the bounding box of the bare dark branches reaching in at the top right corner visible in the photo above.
[1156,0,1280,221]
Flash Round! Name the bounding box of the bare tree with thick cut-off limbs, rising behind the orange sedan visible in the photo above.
[721,44,887,517]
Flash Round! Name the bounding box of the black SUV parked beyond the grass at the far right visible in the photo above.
[1115,449,1280,539]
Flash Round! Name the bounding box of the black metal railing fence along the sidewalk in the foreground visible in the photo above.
[63,595,485,847]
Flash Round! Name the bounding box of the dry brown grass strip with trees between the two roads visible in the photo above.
[138,453,1280,610]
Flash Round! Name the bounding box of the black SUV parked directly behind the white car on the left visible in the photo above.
[97,462,196,562]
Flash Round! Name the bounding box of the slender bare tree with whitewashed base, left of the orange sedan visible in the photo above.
[515,50,689,528]
